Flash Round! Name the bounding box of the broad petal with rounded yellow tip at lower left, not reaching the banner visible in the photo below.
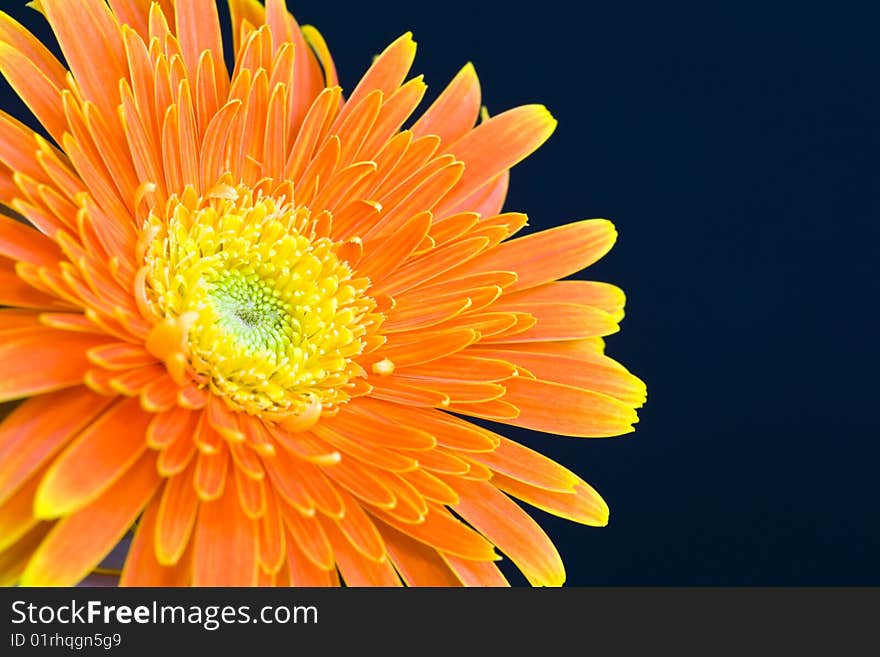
[34,398,150,518]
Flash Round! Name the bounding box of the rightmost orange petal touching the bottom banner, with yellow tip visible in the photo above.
[455,480,565,586]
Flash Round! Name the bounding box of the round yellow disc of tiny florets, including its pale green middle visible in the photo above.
[144,186,375,419]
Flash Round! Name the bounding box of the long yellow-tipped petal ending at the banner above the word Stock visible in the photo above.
[21,453,161,586]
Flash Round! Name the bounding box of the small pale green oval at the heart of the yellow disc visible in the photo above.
[208,270,299,353]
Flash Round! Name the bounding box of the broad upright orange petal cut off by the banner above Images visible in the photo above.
[192,462,259,586]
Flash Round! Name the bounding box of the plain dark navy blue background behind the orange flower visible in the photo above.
[2,0,880,585]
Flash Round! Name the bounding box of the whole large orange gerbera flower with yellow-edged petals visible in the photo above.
[0,0,645,586]
